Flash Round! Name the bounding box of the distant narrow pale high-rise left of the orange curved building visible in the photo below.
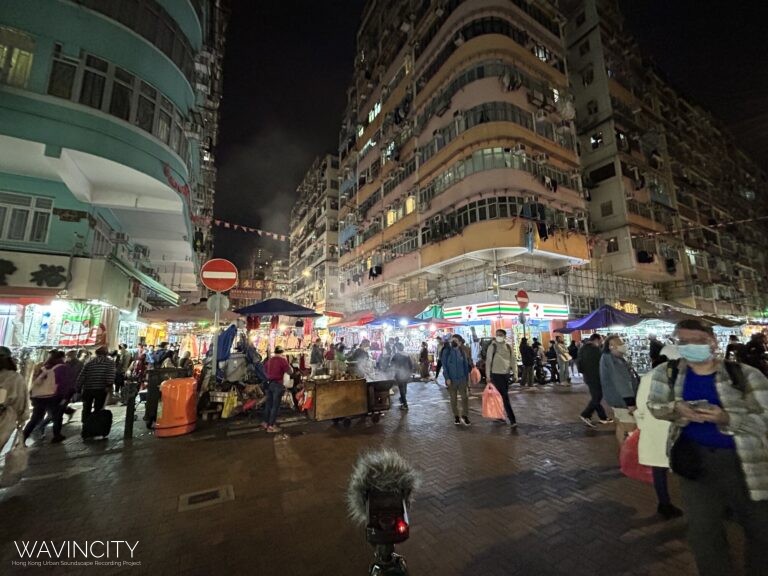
[289,154,340,311]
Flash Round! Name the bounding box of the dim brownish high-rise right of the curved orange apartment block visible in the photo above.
[563,0,768,315]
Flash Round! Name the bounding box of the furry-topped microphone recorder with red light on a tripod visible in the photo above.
[347,449,420,576]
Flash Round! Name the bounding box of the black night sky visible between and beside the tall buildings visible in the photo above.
[215,0,768,266]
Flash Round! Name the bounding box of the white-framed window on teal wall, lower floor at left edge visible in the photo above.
[0,192,53,243]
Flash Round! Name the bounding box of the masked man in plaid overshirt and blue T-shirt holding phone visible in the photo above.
[648,319,768,576]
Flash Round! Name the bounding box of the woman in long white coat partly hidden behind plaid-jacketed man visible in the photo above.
[634,345,683,520]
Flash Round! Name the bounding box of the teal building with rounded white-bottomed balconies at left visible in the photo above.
[0,0,227,346]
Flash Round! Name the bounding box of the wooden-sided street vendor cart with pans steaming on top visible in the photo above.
[304,376,395,428]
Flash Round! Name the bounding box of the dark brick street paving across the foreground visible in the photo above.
[0,383,736,576]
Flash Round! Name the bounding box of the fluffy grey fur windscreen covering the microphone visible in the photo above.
[347,448,420,524]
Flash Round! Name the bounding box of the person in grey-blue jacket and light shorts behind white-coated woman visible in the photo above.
[600,334,638,444]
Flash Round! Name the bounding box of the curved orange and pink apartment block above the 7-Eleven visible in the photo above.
[339,0,590,310]
